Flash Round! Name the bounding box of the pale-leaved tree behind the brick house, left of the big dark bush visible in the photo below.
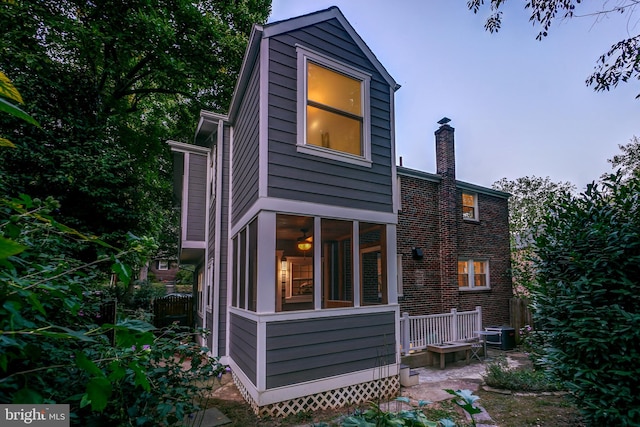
[492,176,575,294]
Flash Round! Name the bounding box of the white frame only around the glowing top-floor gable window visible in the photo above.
[296,45,372,167]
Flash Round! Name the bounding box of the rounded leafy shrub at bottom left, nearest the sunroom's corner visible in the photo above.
[75,321,225,426]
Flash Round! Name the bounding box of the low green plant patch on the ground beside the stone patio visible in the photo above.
[483,357,561,392]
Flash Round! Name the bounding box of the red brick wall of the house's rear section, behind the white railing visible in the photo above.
[397,171,512,326]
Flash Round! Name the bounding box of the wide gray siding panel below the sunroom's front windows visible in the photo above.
[266,312,396,389]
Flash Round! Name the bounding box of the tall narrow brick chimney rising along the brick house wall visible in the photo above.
[435,117,461,313]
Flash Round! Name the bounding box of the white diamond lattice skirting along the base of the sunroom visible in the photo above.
[233,373,400,417]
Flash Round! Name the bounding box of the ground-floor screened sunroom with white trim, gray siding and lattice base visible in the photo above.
[229,211,399,415]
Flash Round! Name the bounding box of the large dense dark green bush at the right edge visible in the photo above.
[533,175,640,426]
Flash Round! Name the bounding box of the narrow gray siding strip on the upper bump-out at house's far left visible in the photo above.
[186,153,208,242]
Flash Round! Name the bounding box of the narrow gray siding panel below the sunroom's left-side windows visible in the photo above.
[229,314,258,385]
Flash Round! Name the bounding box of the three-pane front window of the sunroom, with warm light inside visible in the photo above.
[275,214,388,312]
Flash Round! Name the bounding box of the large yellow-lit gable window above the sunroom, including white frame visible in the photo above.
[297,46,371,166]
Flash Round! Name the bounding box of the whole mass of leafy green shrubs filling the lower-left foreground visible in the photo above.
[0,196,224,426]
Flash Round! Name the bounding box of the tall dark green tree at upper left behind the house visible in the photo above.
[0,0,270,254]
